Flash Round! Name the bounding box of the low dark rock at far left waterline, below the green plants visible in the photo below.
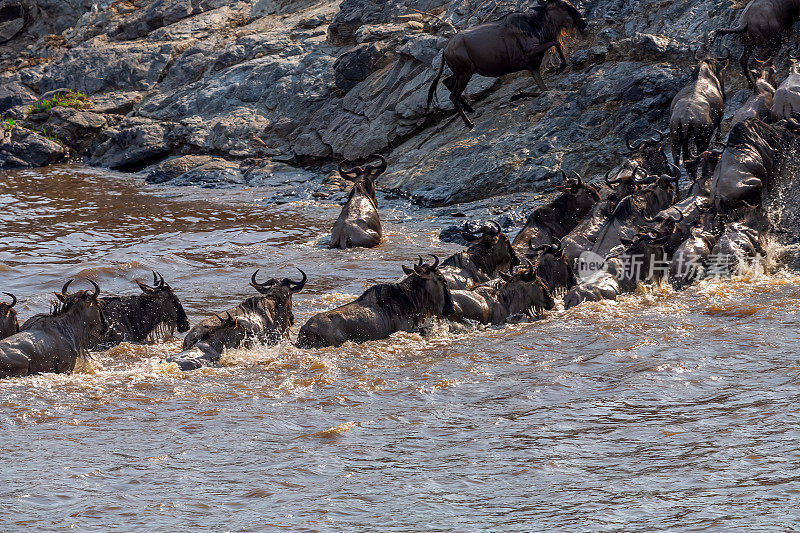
[0,124,66,170]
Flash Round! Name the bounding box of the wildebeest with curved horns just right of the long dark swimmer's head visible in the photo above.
[441,221,519,289]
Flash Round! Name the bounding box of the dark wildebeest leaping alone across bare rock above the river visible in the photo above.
[427,0,588,129]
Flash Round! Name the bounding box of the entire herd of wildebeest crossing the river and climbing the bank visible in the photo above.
[0,0,800,377]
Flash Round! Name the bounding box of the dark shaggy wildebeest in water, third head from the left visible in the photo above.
[91,271,189,347]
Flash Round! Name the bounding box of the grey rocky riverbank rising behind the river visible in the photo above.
[0,0,796,206]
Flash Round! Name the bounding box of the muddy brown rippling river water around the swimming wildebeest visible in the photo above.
[0,167,800,531]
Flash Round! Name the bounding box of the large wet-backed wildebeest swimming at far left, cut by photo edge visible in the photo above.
[0,280,107,377]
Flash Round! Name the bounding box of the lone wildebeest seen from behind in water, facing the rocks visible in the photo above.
[329,154,387,249]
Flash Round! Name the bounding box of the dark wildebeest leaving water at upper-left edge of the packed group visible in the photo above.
[511,170,600,254]
